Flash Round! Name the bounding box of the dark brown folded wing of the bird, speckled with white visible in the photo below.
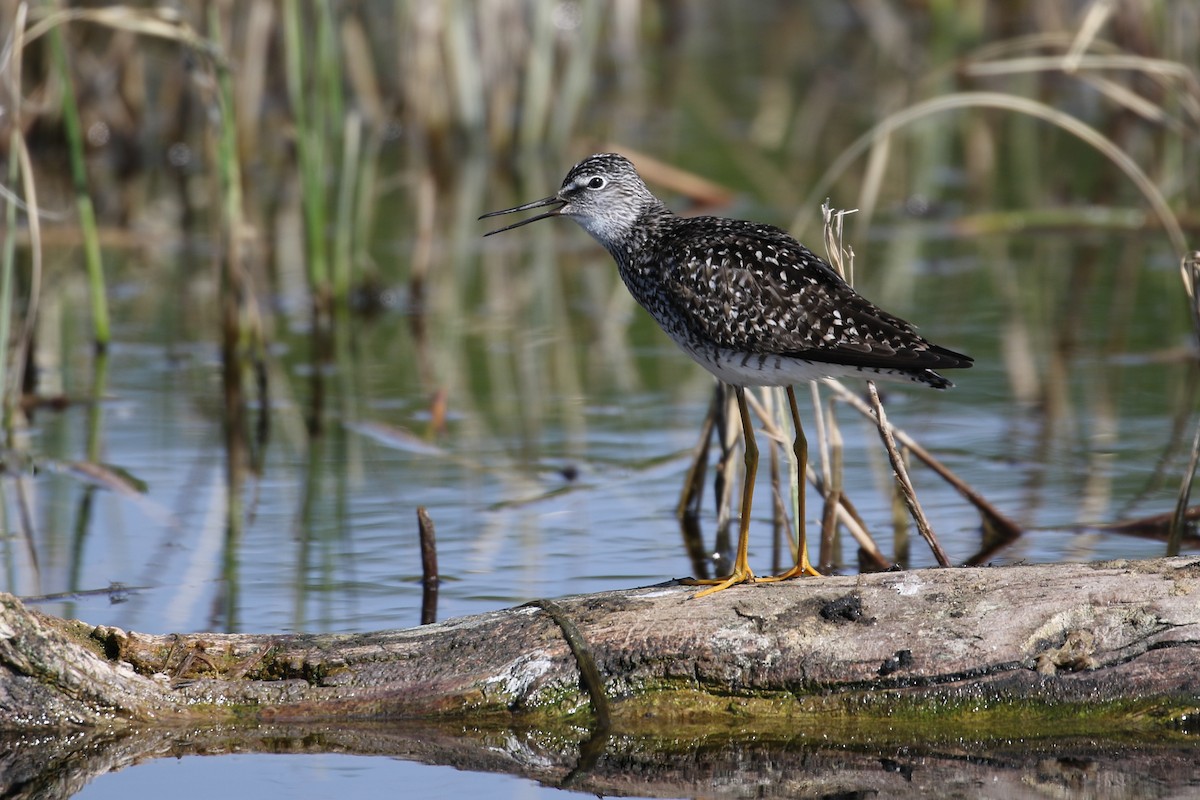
[656,217,971,369]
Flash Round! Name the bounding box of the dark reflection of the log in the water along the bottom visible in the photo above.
[0,721,1200,800]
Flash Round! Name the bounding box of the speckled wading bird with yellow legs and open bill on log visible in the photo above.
[479,152,973,597]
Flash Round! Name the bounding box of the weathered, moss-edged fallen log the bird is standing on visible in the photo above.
[0,558,1200,734]
